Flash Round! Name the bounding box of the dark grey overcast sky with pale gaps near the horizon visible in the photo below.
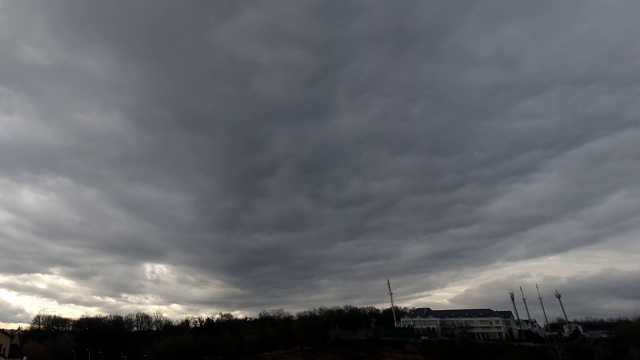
[0,0,640,323]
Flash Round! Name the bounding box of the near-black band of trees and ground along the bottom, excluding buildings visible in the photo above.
[13,306,640,360]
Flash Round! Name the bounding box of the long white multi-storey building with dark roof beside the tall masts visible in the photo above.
[400,308,518,340]
